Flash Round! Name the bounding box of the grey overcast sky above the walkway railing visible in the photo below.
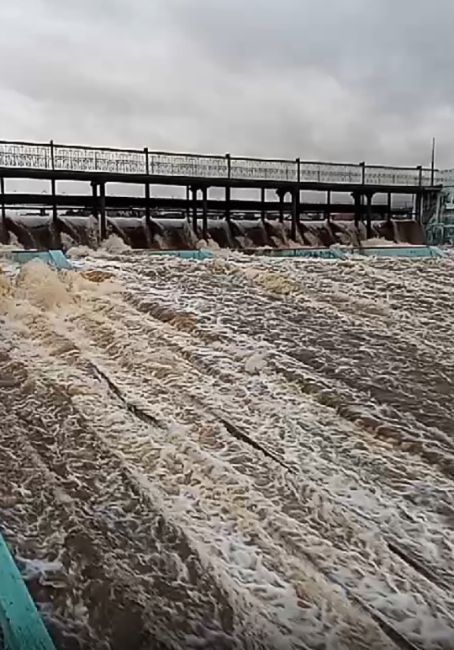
[0,0,454,166]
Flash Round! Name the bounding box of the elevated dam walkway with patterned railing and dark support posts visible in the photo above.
[0,141,444,237]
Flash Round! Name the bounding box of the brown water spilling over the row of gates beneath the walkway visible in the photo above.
[0,215,424,250]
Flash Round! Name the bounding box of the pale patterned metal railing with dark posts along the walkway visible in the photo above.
[0,141,440,187]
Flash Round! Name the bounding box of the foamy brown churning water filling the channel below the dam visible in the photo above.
[0,251,454,650]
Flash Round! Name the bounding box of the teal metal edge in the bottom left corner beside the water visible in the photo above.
[0,535,55,650]
